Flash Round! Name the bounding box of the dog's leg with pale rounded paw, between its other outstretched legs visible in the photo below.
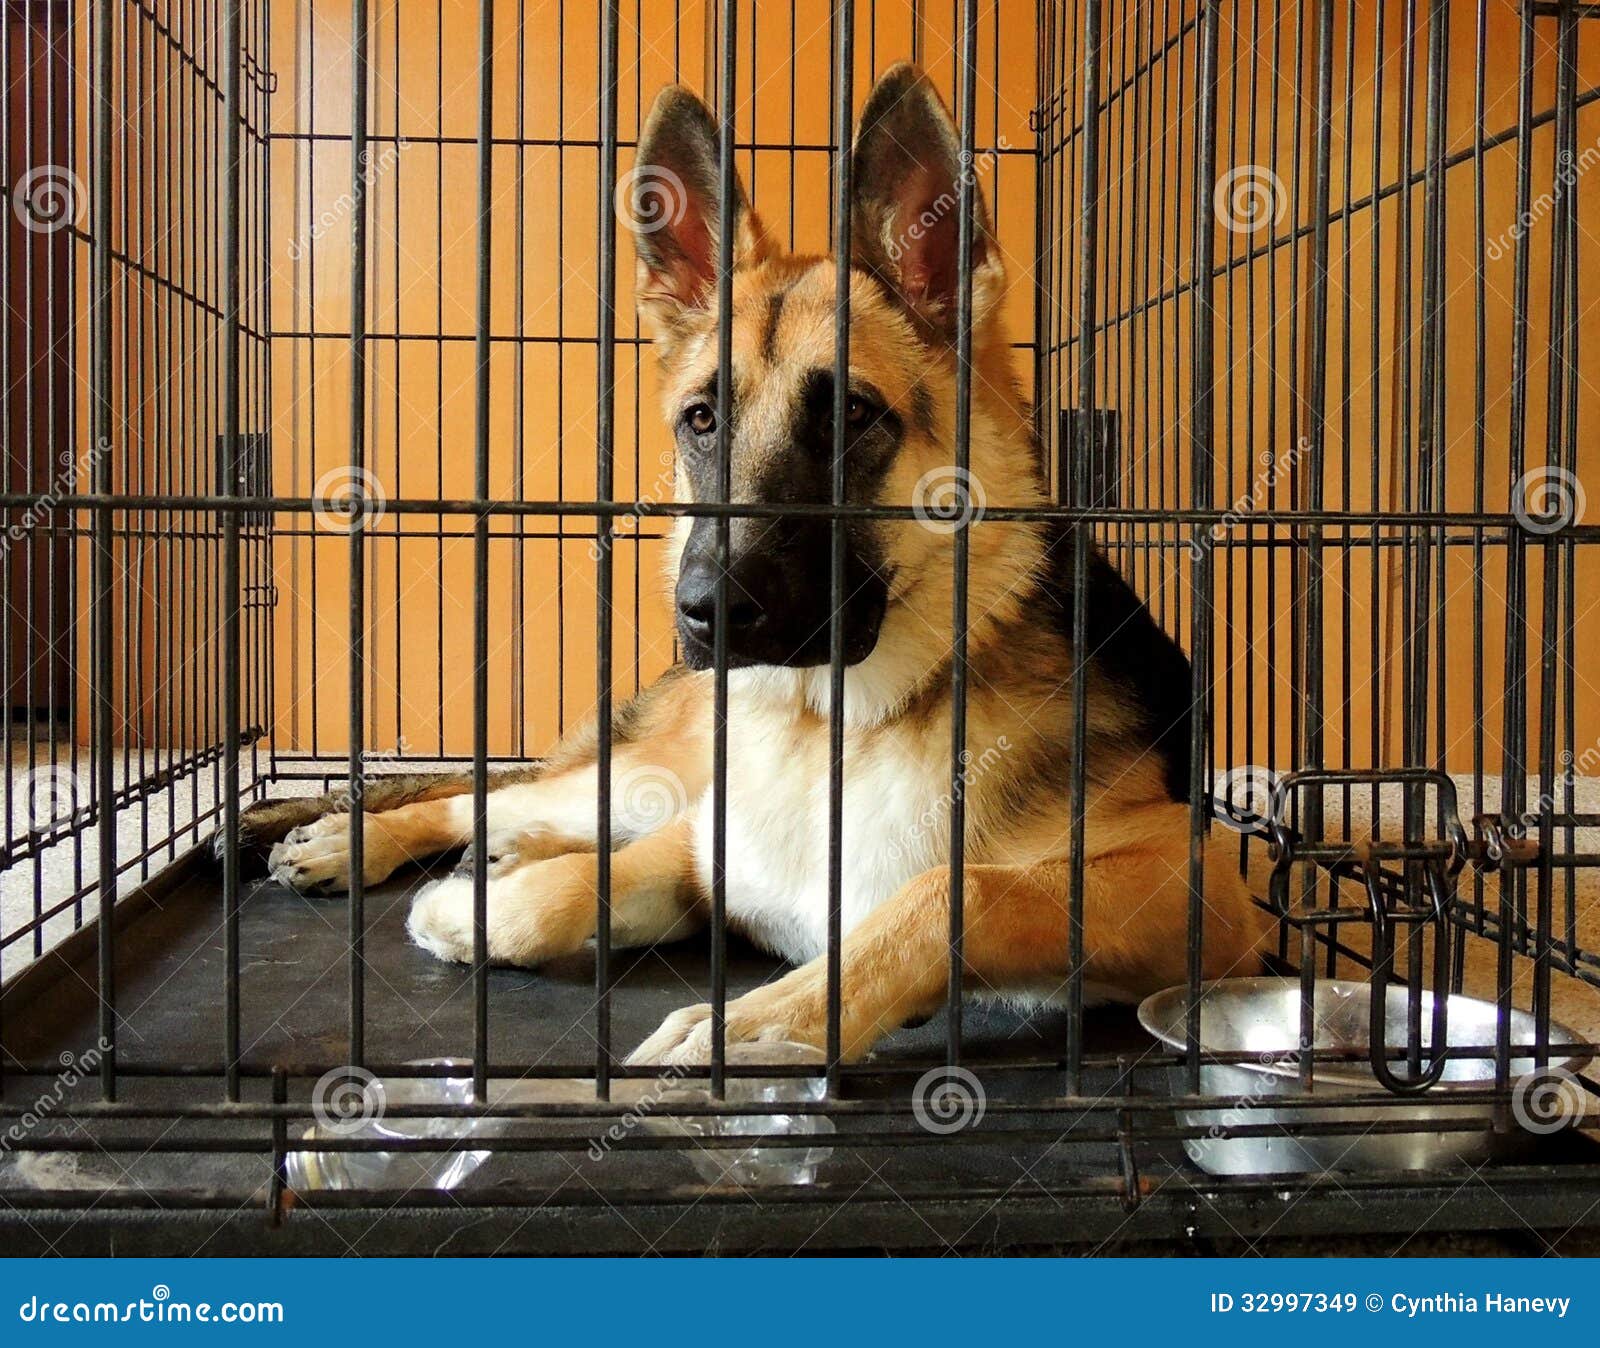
[406,815,706,965]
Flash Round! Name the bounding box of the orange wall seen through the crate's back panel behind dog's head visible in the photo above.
[272,0,1035,754]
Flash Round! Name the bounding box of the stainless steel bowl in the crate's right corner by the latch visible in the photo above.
[1139,978,1589,1175]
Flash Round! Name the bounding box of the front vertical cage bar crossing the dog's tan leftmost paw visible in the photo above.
[346,0,368,1066]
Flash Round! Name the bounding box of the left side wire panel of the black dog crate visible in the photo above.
[0,0,272,977]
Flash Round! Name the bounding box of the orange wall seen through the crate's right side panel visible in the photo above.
[1061,0,1600,772]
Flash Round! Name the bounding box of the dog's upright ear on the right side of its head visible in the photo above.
[850,66,1005,338]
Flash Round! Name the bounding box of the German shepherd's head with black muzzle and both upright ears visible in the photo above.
[632,66,1032,682]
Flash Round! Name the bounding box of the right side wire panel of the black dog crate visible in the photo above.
[1040,5,1600,1015]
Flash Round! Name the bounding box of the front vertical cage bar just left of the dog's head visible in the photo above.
[595,0,619,1100]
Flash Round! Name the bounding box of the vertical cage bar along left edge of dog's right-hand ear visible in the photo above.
[827,0,856,1092]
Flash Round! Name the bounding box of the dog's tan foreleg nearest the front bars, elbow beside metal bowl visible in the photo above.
[629,805,1266,1065]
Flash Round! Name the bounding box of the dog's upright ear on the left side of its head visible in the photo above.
[626,85,770,333]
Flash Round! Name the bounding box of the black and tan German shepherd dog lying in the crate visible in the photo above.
[243,66,1264,1063]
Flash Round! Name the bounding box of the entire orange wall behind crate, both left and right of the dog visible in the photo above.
[262,0,1600,768]
